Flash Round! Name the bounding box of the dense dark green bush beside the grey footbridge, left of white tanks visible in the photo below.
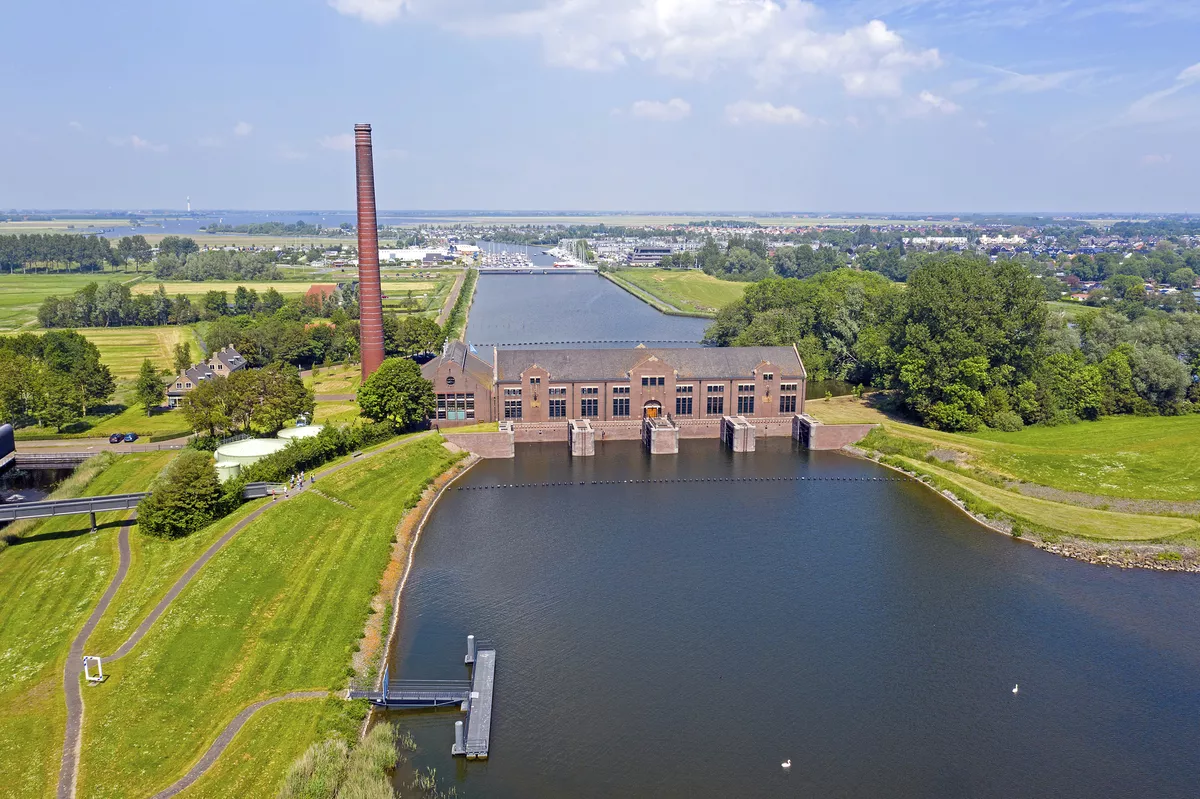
[138,451,223,539]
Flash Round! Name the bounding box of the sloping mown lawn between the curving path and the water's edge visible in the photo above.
[79,437,460,797]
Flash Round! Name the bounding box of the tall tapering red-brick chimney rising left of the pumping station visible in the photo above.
[354,125,383,380]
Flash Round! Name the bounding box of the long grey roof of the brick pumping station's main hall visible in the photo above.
[496,347,806,383]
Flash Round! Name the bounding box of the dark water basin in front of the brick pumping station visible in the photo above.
[391,277,1200,799]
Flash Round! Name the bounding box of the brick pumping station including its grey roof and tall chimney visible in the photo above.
[354,125,869,457]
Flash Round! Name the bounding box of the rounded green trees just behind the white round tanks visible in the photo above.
[182,364,314,437]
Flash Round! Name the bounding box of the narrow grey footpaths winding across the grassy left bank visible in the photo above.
[56,432,433,799]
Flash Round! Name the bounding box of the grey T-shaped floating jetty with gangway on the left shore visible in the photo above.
[347,636,496,761]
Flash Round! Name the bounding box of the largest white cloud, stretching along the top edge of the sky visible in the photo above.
[329,0,941,96]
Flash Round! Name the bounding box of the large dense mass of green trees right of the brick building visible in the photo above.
[707,256,1200,431]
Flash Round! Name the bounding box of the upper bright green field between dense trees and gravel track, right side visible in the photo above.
[805,397,1200,501]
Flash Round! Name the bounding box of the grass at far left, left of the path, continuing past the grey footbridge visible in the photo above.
[0,452,175,797]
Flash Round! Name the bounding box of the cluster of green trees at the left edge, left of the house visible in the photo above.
[0,330,116,429]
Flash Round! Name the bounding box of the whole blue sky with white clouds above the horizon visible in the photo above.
[0,0,1200,211]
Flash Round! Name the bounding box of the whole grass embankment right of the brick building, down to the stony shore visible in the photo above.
[806,397,1200,545]
